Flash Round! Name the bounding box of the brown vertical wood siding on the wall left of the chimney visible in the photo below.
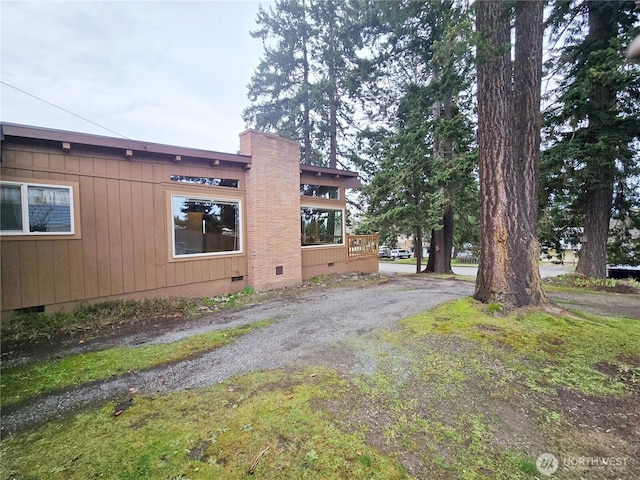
[0,138,247,313]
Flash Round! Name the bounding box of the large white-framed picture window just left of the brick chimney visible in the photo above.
[171,195,242,257]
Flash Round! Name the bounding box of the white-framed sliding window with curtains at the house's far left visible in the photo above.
[0,182,74,235]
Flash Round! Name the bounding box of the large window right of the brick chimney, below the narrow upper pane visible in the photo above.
[300,207,344,247]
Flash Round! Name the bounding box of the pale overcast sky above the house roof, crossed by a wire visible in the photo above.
[0,0,268,153]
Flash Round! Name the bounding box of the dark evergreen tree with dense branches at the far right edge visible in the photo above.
[541,0,640,278]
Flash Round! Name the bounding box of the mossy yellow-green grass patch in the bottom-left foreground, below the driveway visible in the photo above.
[0,370,407,480]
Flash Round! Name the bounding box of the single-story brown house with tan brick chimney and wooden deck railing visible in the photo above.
[0,123,378,315]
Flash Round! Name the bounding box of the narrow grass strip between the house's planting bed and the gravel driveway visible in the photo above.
[0,321,271,407]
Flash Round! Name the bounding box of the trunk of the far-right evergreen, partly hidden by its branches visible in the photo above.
[576,2,617,278]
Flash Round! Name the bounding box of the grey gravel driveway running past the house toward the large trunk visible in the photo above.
[1,275,474,436]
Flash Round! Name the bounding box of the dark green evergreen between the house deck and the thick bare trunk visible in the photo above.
[358,1,477,272]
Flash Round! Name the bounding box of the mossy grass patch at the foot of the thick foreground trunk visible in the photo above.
[403,299,640,394]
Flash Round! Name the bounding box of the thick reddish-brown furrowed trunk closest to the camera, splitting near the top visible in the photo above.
[474,0,547,308]
